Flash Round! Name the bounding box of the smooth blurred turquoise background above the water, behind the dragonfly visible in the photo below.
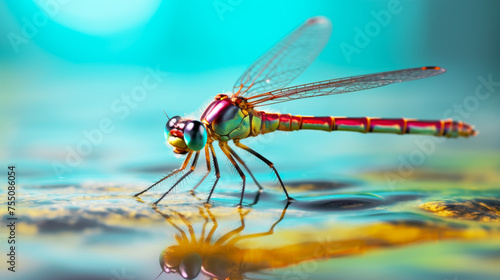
[0,0,500,183]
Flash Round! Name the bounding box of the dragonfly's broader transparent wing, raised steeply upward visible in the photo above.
[233,17,332,97]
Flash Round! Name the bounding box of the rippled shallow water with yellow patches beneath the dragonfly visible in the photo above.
[2,153,500,279]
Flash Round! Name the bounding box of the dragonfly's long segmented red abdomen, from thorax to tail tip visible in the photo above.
[261,112,476,138]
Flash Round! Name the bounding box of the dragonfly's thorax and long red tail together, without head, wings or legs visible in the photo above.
[201,95,476,141]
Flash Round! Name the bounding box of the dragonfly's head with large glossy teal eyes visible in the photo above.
[165,116,208,155]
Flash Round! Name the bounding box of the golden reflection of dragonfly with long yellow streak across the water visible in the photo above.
[153,198,500,279]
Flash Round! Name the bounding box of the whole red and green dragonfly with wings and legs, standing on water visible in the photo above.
[135,16,477,207]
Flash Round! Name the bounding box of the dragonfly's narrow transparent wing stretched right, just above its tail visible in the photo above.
[248,66,446,107]
